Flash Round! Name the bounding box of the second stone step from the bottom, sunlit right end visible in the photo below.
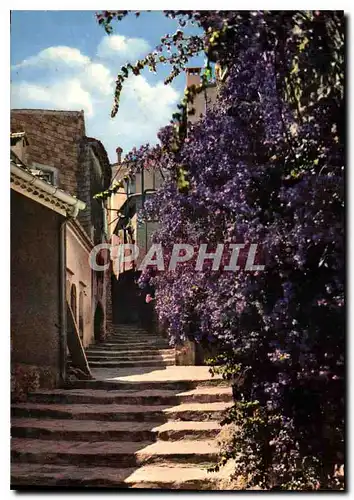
[11,438,219,468]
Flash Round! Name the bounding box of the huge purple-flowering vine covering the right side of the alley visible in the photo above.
[99,11,345,490]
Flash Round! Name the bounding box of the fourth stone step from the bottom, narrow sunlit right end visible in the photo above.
[11,402,232,422]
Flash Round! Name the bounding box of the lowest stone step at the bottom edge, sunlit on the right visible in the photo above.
[11,463,220,490]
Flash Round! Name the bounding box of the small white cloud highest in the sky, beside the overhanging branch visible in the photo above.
[97,35,150,62]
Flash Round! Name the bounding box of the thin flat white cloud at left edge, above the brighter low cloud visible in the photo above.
[13,46,90,68]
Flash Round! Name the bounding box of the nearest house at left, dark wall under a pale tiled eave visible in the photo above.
[10,145,85,395]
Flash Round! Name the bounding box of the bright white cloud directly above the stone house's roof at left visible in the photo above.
[11,78,93,116]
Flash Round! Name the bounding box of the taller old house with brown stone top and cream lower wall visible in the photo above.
[11,109,111,347]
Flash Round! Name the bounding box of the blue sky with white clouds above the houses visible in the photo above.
[11,11,204,162]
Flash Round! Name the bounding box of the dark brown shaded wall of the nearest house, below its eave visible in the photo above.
[11,191,64,384]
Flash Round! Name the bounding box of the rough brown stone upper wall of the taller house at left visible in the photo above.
[11,109,111,244]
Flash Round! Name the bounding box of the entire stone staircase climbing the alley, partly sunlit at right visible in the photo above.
[11,324,232,490]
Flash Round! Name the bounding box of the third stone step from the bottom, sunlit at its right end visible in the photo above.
[11,418,221,442]
